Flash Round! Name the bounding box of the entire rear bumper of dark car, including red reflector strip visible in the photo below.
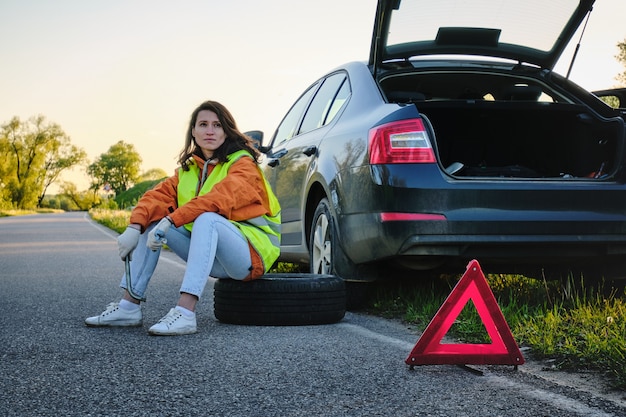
[336,164,626,274]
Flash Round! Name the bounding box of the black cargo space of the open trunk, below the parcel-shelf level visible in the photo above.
[404,100,623,180]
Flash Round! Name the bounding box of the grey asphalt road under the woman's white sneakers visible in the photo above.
[0,213,626,417]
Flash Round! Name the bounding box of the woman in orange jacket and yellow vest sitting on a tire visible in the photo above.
[85,101,280,335]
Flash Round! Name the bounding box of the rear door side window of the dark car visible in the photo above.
[298,73,349,134]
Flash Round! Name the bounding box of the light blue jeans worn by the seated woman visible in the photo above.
[120,213,252,298]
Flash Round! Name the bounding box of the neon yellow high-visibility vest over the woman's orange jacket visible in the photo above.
[178,150,281,272]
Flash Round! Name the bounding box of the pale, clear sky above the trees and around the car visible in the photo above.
[0,0,626,191]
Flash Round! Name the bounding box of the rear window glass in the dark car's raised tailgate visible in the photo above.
[369,0,595,70]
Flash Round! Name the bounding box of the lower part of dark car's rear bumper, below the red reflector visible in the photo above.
[340,213,626,274]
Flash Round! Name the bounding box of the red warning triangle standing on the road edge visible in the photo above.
[405,260,524,365]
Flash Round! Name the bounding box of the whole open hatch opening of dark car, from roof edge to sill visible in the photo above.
[379,62,624,180]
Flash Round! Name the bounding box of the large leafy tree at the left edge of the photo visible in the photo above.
[0,115,86,209]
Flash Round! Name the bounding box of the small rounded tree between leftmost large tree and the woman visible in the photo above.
[87,141,141,194]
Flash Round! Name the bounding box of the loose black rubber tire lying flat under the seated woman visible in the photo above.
[214,274,346,326]
